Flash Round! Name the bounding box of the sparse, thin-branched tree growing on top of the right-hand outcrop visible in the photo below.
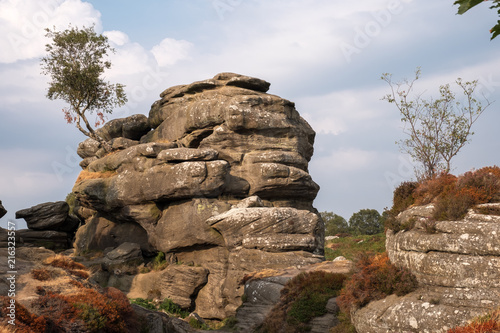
[381,68,491,179]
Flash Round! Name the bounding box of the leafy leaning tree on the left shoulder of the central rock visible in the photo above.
[41,27,127,151]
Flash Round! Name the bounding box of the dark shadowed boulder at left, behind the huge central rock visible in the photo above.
[16,201,80,232]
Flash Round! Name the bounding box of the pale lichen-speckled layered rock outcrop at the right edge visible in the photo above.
[353,204,500,333]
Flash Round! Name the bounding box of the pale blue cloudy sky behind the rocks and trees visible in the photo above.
[0,0,500,227]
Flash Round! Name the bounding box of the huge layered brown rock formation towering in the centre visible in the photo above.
[73,73,324,319]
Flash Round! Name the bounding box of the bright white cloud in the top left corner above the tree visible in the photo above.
[0,0,100,63]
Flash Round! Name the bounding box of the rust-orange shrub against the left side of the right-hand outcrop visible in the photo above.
[338,252,418,314]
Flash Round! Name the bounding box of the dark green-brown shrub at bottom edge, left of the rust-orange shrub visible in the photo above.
[260,271,346,333]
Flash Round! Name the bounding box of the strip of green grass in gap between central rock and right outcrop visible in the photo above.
[325,233,385,260]
